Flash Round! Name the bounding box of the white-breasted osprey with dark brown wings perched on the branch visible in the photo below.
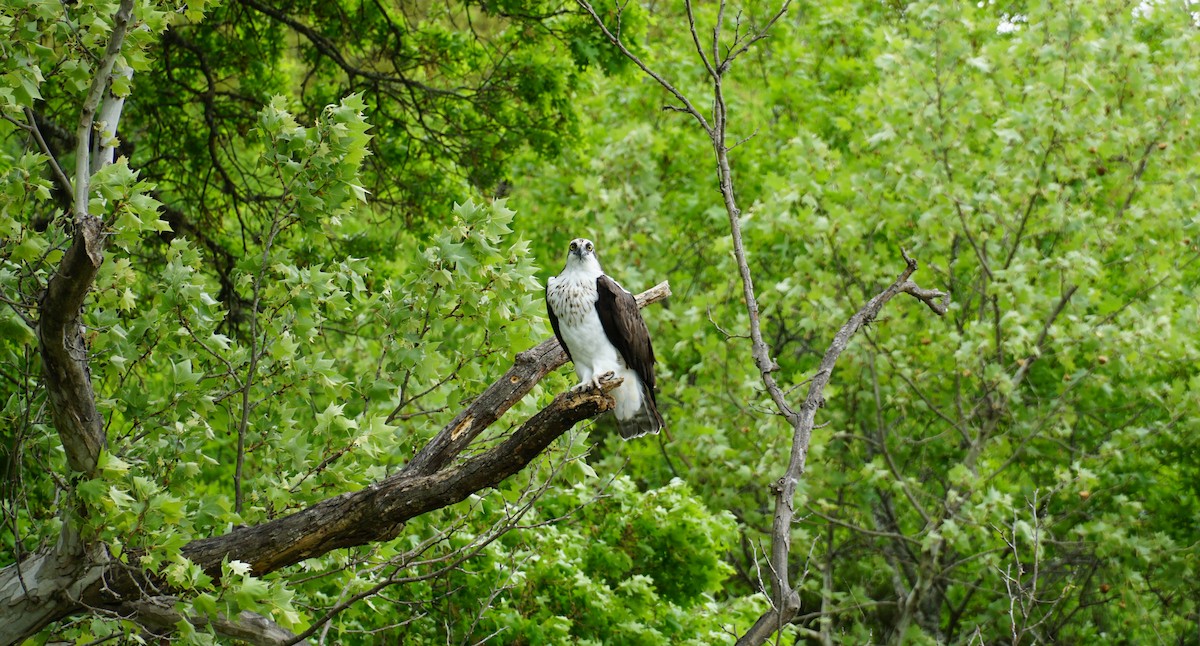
[546,238,662,439]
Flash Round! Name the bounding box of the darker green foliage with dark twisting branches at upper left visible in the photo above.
[119,0,611,225]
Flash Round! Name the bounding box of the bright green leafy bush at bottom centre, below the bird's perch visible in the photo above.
[296,470,758,644]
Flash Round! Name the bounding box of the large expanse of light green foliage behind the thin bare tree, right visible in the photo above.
[515,2,1200,644]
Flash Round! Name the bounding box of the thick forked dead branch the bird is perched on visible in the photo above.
[0,282,671,644]
